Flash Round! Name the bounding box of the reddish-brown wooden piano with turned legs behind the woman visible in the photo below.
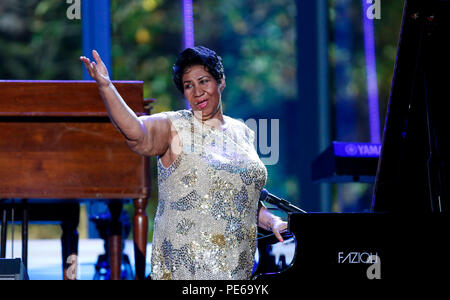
[0,81,151,279]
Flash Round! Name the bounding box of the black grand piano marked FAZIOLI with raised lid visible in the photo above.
[254,0,450,282]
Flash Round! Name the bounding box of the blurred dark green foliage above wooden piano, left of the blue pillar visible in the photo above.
[0,0,82,80]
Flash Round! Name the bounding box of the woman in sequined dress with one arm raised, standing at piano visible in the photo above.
[80,46,287,279]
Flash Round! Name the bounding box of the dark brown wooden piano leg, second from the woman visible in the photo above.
[108,201,123,280]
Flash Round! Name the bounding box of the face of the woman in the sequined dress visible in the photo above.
[182,65,225,120]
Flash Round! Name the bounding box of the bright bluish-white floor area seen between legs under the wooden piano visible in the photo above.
[6,239,151,280]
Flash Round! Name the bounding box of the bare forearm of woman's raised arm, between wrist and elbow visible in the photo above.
[99,83,145,143]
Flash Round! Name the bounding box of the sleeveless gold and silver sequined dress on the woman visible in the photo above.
[151,110,267,280]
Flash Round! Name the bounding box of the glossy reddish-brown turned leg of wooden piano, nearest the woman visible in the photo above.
[133,198,148,280]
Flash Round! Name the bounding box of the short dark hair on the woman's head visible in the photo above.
[172,46,224,94]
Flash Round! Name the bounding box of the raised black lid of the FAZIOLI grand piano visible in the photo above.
[372,0,450,212]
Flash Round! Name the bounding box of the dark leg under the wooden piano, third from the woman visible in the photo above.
[61,203,80,280]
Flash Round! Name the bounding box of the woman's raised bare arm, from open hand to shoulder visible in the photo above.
[80,50,171,155]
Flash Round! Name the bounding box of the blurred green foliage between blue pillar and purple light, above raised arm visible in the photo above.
[111,0,183,113]
